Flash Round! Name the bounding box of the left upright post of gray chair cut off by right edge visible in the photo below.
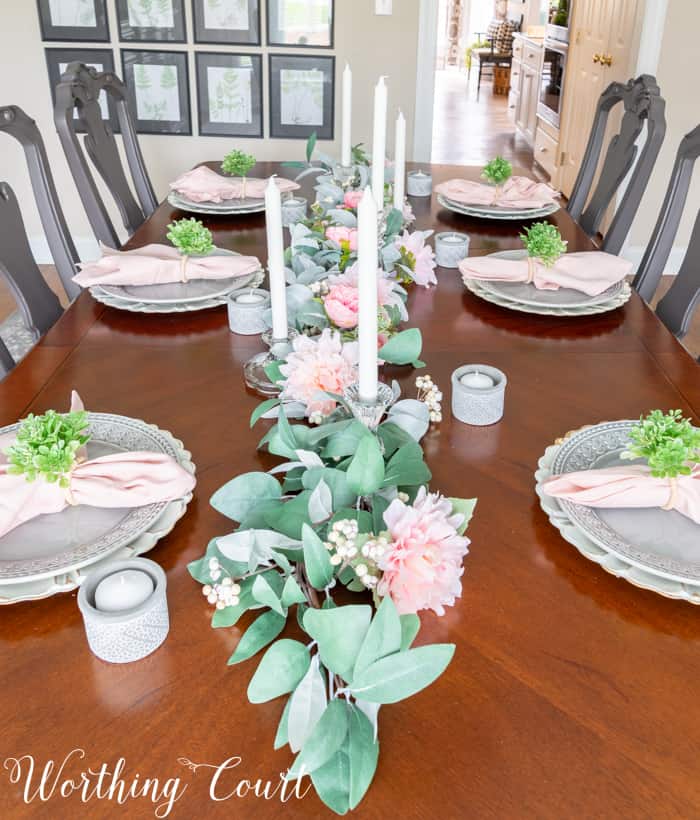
[632,125,700,302]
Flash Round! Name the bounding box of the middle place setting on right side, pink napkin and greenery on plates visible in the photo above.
[458,222,632,316]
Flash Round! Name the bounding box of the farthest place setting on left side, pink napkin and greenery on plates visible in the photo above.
[168,150,299,216]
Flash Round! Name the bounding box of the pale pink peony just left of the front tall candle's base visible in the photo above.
[280,328,358,417]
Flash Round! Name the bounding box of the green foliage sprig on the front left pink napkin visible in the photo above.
[5,410,90,487]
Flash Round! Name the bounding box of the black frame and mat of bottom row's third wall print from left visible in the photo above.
[195,51,264,139]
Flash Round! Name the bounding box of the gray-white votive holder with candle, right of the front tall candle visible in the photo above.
[452,364,508,427]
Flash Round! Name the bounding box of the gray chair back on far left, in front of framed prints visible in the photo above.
[54,63,157,248]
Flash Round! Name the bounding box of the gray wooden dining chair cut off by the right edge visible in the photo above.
[632,125,700,348]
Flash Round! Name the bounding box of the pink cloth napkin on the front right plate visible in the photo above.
[543,464,700,524]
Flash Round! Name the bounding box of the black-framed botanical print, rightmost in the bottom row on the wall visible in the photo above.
[269,54,335,140]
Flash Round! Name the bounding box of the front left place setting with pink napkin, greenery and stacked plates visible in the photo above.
[0,392,195,603]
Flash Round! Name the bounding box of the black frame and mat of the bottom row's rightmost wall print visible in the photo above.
[268,54,335,140]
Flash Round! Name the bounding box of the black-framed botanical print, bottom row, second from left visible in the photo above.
[122,49,192,134]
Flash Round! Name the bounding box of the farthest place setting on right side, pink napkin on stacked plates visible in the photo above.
[435,157,560,221]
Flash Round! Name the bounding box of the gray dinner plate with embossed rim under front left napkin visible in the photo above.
[0,413,187,585]
